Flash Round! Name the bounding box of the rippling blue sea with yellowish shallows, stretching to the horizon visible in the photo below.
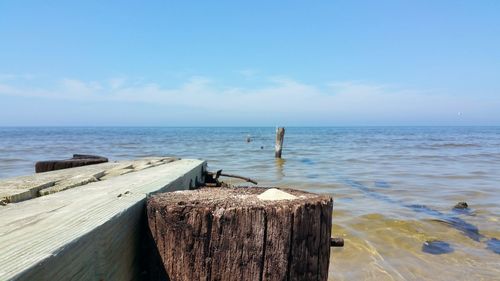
[0,127,500,280]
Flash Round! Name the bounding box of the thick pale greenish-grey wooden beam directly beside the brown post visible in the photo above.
[0,160,205,280]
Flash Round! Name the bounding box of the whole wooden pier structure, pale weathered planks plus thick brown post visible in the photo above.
[0,157,333,281]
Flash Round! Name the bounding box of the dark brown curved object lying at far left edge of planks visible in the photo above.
[35,154,108,173]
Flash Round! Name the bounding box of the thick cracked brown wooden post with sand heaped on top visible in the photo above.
[147,187,333,281]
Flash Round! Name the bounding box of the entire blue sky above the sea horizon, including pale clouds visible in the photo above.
[0,0,500,126]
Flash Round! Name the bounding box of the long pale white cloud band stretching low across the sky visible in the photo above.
[0,76,500,124]
